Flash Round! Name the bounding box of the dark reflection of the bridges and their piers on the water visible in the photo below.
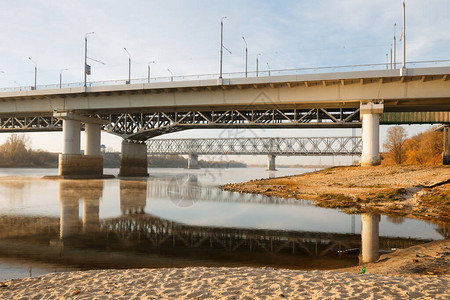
[0,176,442,269]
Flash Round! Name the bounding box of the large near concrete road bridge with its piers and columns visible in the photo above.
[0,67,450,176]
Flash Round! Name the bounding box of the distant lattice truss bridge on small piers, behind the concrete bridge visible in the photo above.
[147,137,362,170]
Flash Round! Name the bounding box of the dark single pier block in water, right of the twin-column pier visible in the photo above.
[119,140,148,177]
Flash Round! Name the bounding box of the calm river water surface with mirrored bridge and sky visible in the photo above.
[0,168,446,280]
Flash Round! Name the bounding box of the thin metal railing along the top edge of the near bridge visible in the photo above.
[0,60,450,93]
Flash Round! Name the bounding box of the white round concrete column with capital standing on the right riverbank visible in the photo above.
[360,102,384,166]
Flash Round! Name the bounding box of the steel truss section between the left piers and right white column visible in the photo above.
[103,108,361,141]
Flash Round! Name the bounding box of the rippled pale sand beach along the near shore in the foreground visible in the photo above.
[0,267,450,299]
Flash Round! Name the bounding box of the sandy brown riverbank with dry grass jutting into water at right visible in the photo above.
[222,166,450,224]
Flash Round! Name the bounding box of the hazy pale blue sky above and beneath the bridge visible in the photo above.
[0,0,450,164]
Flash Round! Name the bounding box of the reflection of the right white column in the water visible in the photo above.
[361,214,380,263]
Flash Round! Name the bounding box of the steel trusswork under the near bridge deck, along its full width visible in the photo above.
[0,107,450,142]
